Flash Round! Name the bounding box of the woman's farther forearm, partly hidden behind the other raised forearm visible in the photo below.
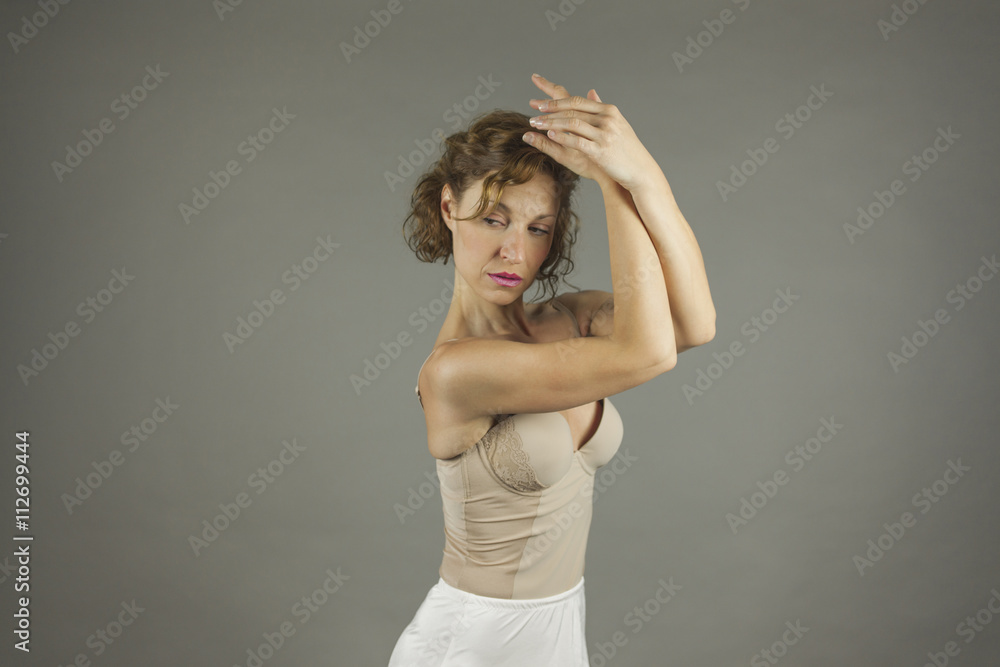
[628,168,715,351]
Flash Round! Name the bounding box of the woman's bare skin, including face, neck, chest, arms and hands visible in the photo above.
[417,77,714,460]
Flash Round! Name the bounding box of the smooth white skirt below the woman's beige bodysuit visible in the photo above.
[388,577,589,667]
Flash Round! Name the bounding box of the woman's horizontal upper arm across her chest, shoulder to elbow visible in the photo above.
[425,336,671,418]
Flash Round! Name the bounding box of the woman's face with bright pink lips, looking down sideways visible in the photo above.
[441,173,558,304]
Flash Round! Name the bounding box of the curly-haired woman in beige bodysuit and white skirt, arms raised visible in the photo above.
[389,75,715,667]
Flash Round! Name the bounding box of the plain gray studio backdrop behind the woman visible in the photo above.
[0,0,1000,667]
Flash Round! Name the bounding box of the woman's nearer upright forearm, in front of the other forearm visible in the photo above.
[601,180,676,362]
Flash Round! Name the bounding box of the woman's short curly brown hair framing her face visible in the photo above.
[403,109,580,306]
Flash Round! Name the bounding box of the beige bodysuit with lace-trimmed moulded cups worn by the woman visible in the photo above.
[416,299,624,599]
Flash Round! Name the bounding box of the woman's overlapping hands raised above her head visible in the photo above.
[525,75,662,191]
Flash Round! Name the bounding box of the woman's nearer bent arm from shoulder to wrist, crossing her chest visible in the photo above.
[421,174,677,426]
